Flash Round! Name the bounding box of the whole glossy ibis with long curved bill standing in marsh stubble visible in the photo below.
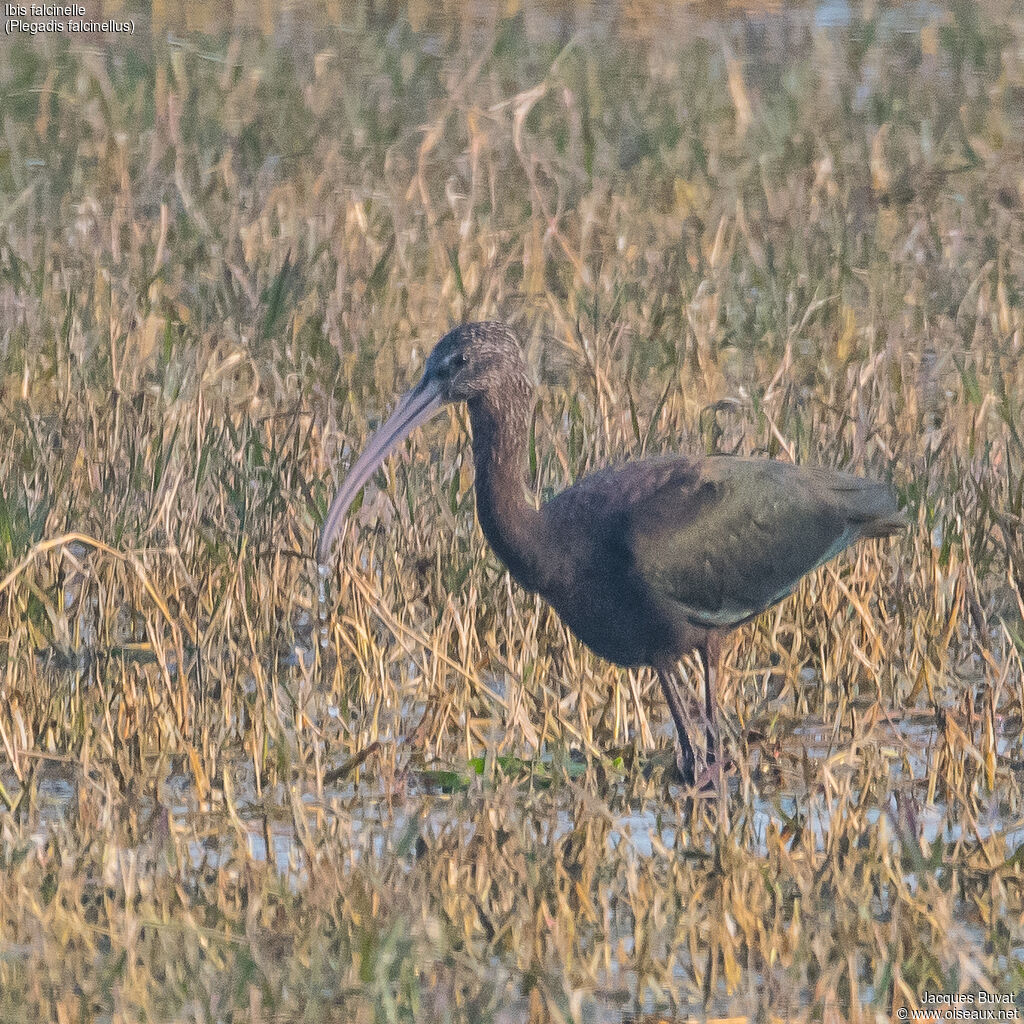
[318,323,904,782]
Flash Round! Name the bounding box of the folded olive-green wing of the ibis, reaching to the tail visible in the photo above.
[622,458,898,628]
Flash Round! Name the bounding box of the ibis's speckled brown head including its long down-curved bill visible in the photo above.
[317,322,526,562]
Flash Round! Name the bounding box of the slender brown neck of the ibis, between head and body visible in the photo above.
[469,374,545,591]
